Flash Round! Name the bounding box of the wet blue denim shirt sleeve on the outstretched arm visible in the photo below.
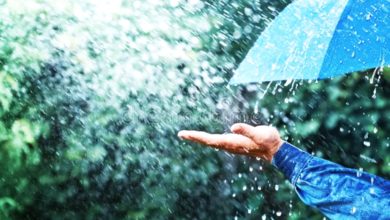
[272,142,390,220]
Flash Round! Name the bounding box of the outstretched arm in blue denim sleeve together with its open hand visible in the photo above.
[179,124,390,219]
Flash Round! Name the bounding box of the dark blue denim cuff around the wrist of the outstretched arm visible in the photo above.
[271,142,313,186]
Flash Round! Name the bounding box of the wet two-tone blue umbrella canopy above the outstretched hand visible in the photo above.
[230,0,390,84]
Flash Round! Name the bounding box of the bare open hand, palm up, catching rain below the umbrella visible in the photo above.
[178,123,283,162]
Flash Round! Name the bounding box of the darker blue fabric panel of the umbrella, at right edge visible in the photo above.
[318,0,390,78]
